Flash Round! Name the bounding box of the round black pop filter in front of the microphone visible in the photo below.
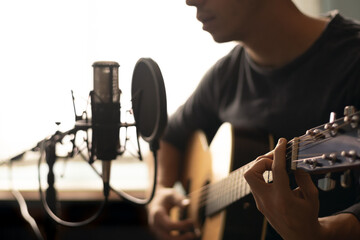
[131,58,168,142]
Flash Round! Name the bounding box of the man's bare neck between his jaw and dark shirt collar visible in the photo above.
[242,5,329,68]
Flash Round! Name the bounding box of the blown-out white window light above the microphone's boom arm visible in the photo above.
[0,0,233,160]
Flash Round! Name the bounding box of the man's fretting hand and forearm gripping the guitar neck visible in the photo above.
[245,139,360,240]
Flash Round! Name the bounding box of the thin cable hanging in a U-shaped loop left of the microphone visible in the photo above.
[38,141,108,227]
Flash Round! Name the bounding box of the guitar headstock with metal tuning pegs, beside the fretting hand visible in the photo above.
[287,107,360,174]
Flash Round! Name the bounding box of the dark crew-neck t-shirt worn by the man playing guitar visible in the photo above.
[163,14,360,238]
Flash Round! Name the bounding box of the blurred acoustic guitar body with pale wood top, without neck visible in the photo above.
[181,123,269,240]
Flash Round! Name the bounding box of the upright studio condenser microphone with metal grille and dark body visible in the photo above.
[90,61,121,195]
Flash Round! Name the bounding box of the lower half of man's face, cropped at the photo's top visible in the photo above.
[186,0,266,42]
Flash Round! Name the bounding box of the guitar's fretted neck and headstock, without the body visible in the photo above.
[190,106,360,219]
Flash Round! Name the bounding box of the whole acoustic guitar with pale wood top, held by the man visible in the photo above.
[172,107,360,240]
